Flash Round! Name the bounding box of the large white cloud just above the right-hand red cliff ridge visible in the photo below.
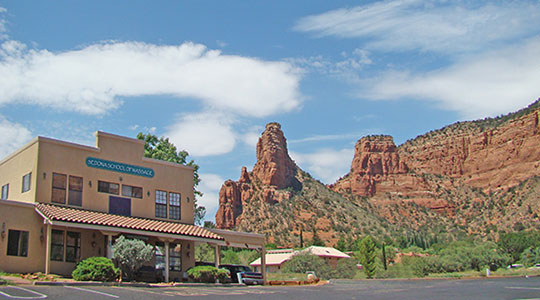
[359,37,540,119]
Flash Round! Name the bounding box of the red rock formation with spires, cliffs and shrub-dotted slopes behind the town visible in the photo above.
[216,100,540,247]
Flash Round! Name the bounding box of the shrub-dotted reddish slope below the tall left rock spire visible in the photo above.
[232,171,410,247]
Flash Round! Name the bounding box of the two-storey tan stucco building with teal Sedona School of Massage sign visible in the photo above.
[0,132,264,281]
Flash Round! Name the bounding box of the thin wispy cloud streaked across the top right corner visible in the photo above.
[295,0,540,54]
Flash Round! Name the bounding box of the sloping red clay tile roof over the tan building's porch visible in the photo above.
[36,203,224,240]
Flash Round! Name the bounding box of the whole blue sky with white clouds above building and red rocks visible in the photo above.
[0,0,540,220]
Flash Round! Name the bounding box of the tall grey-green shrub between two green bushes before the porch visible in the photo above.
[112,236,154,280]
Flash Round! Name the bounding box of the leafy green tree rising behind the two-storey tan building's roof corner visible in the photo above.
[137,132,206,225]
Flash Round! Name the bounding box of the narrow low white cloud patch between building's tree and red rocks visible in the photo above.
[197,173,225,222]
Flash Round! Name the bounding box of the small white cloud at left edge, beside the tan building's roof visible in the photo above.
[0,116,32,159]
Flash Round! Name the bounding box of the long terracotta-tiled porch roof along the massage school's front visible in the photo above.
[35,203,224,242]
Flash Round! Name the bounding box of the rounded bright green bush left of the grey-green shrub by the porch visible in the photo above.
[71,257,119,281]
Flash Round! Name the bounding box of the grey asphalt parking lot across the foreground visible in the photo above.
[0,277,540,300]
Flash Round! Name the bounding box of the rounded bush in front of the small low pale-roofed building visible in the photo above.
[283,253,332,279]
